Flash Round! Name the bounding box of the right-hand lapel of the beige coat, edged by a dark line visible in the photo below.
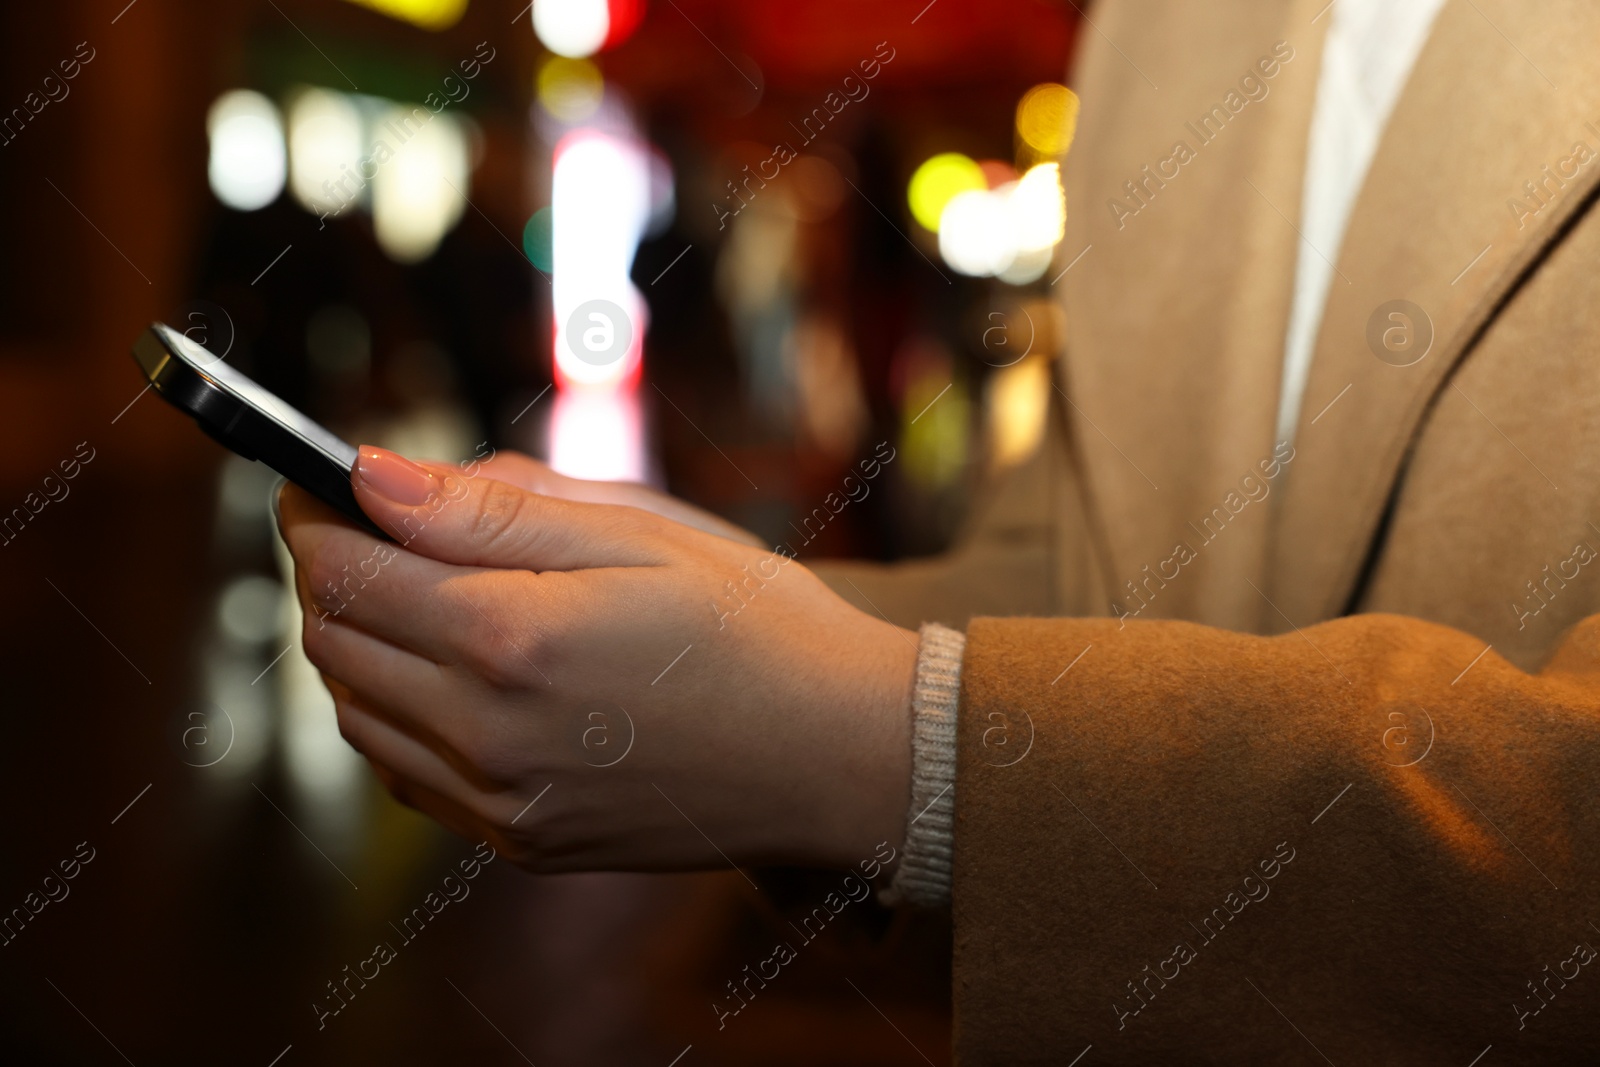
[1266,0,1600,630]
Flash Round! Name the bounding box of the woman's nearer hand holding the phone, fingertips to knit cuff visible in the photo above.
[280,448,917,870]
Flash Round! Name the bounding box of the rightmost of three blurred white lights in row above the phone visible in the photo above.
[372,106,469,262]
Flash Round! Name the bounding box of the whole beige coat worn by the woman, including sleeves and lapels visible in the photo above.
[829,0,1600,1067]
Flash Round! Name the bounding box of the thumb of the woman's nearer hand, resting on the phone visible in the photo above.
[350,445,669,571]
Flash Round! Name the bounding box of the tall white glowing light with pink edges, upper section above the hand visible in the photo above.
[550,130,650,386]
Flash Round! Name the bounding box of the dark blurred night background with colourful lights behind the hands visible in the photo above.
[0,0,1077,1067]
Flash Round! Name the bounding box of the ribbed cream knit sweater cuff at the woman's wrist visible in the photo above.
[882,622,966,909]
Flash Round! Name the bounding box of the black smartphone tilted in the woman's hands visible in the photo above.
[133,323,389,539]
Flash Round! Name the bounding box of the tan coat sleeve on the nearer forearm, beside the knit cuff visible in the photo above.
[954,614,1600,1065]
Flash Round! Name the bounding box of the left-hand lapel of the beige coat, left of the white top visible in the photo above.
[1059,0,1328,630]
